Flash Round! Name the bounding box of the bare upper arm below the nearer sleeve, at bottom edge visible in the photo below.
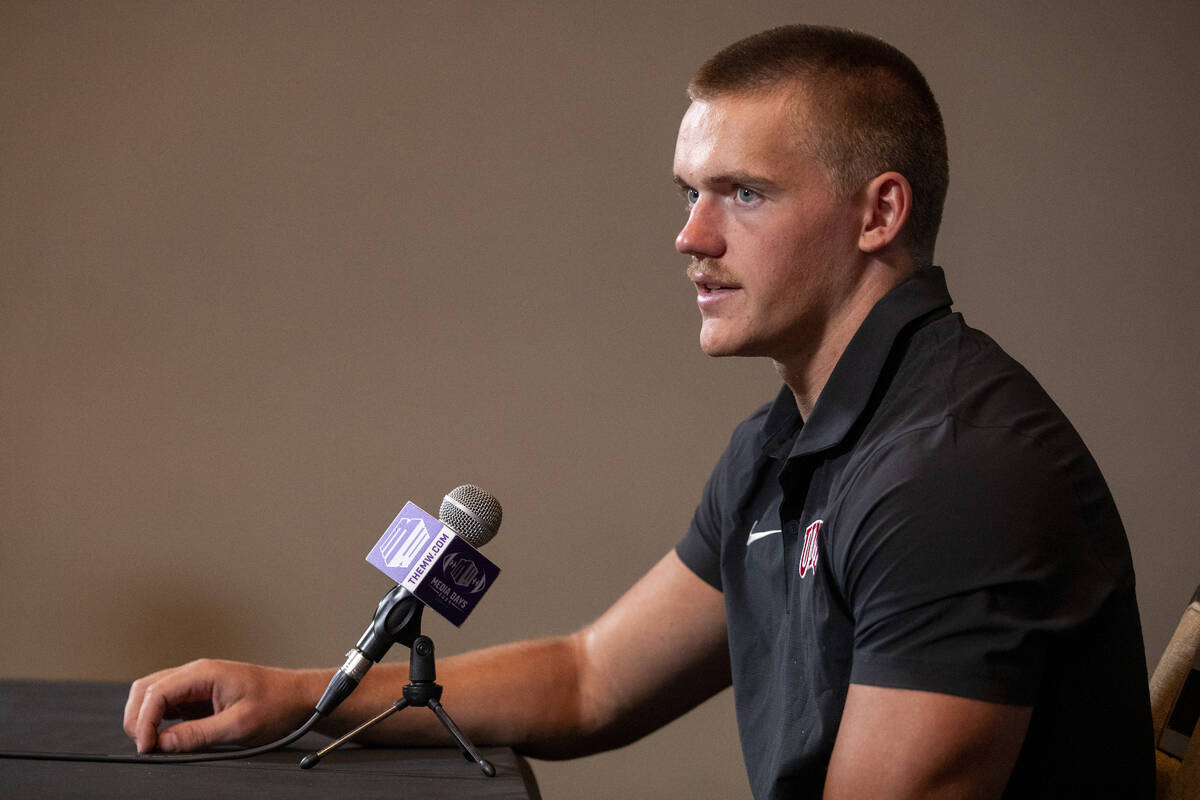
[824,684,1032,800]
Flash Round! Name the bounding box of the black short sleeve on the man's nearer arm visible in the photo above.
[833,420,1117,705]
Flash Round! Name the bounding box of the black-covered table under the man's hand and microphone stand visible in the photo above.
[0,680,540,800]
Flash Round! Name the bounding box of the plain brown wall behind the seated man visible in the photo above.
[0,0,1200,798]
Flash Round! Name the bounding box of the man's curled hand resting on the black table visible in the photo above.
[125,658,329,753]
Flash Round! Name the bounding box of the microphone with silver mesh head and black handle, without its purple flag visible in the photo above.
[317,483,504,716]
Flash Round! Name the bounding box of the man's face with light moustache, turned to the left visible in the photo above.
[674,92,860,363]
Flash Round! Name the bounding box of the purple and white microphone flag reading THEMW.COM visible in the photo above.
[367,503,500,626]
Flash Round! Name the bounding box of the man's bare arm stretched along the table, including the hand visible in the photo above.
[125,551,730,758]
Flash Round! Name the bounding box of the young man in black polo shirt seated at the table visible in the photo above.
[125,26,1153,798]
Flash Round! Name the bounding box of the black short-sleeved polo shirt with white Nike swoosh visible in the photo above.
[677,267,1154,800]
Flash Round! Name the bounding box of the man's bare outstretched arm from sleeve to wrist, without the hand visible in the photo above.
[304,551,730,758]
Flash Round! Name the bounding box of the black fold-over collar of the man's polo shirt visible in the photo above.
[762,266,952,458]
